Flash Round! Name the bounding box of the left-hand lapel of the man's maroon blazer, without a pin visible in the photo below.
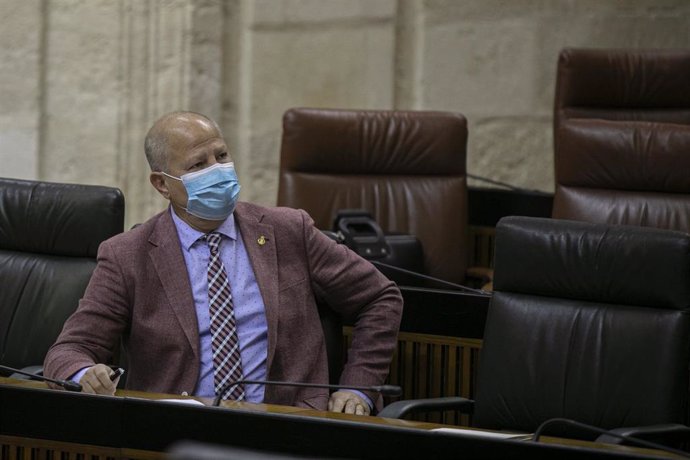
[149,209,200,358]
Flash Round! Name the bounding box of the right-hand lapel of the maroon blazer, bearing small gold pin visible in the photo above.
[235,203,278,371]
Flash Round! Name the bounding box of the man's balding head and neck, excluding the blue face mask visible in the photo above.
[144,112,232,232]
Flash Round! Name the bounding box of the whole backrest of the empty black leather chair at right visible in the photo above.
[474,217,690,432]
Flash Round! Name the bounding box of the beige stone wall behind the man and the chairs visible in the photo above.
[0,0,690,225]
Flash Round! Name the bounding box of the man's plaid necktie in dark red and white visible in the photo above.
[203,232,245,401]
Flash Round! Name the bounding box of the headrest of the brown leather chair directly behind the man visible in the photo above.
[280,108,467,175]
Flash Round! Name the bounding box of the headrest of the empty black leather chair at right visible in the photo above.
[494,217,690,310]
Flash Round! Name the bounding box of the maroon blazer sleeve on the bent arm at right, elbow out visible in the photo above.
[302,211,403,401]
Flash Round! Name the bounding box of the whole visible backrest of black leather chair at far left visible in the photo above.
[0,178,124,367]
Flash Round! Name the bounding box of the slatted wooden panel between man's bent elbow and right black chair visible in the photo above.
[344,327,482,426]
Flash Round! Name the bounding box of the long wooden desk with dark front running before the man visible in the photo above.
[0,378,672,460]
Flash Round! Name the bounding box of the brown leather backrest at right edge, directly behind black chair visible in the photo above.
[552,119,690,232]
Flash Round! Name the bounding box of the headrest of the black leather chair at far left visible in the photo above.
[0,178,124,257]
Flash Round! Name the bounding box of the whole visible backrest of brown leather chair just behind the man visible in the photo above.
[278,108,467,283]
